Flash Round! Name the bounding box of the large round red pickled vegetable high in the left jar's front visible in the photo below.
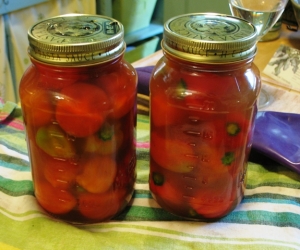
[56,82,110,137]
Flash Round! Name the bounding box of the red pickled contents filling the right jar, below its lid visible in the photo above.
[149,54,260,220]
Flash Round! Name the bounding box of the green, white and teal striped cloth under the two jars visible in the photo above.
[0,108,300,250]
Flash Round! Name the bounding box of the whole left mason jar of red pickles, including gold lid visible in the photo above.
[19,14,137,223]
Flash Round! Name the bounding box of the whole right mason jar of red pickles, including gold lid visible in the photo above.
[149,13,260,220]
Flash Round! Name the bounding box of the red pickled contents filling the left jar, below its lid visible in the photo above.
[20,57,136,223]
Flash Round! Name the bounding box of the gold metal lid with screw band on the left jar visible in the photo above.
[28,14,126,66]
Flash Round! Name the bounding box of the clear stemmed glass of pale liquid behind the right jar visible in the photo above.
[229,0,288,108]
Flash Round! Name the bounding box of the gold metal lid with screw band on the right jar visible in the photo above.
[162,13,257,63]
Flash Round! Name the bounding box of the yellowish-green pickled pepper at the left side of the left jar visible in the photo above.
[35,124,76,159]
